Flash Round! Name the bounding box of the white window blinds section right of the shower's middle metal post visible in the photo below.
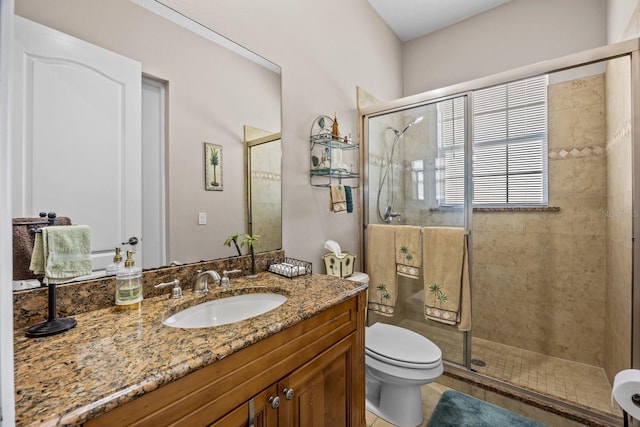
[472,76,548,205]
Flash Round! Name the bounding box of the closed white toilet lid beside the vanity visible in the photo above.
[365,322,442,369]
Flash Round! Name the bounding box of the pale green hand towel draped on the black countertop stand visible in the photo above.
[29,225,92,283]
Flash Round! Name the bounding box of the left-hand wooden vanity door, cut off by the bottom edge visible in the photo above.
[209,384,278,427]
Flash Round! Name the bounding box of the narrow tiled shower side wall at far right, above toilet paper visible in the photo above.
[604,58,637,383]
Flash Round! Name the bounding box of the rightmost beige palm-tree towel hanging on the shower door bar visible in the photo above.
[422,227,471,331]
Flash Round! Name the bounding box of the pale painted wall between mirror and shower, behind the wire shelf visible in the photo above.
[163,0,402,273]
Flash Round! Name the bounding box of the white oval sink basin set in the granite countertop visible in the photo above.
[162,293,287,328]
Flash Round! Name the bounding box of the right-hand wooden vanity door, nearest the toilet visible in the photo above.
[278,334,356,427]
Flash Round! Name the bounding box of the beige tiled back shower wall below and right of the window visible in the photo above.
[473,74,607,366]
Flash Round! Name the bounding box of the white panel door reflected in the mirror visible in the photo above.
[13,16,142,270]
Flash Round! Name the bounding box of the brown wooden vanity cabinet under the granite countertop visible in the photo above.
[86,292,365,427]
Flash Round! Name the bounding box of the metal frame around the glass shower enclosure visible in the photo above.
[358,38,640,404]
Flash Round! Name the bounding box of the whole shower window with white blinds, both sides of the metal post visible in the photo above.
[437,76,548,206]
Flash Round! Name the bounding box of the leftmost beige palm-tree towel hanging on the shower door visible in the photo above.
[367,224,398,316]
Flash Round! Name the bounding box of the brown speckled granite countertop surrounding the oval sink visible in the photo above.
[14,273,366,426]
